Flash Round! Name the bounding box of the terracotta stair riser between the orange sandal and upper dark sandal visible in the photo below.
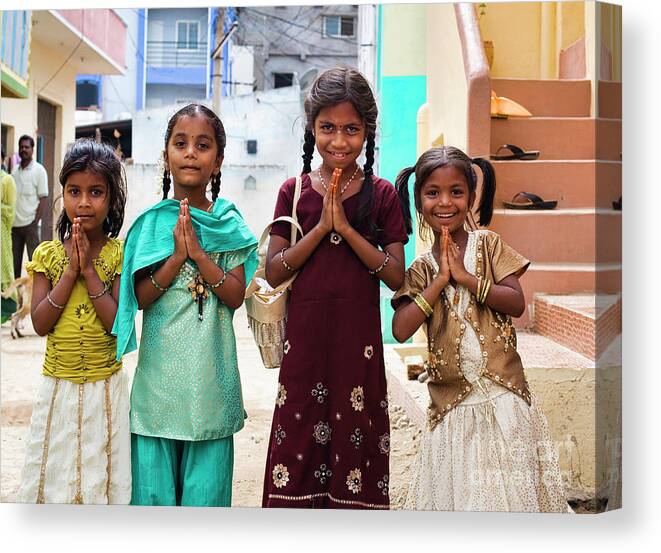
[491,117,622,161]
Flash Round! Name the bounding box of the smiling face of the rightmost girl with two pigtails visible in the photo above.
[420,164,473,233]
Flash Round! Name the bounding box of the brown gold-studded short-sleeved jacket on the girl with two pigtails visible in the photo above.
[392,230,530,429]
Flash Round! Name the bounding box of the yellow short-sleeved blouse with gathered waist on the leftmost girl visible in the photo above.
[27,238,122,384]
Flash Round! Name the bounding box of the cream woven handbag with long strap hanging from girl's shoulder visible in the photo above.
[245,177,303,369]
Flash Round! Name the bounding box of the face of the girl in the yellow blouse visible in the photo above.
[63,171,110,234]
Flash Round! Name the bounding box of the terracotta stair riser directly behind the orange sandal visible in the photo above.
[491,79,588,117]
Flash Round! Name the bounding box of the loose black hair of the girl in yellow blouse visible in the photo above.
[56,138,126,242]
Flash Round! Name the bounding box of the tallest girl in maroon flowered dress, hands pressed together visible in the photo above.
[262,68,408,509]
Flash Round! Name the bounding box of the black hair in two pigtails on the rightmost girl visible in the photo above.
[395,146,496,237]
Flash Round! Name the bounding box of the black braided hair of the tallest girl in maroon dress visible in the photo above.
[303,67,379,238]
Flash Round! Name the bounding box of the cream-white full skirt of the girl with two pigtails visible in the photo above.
[404,379,571,512]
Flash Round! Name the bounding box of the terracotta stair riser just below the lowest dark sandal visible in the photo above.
[489,209,622,264]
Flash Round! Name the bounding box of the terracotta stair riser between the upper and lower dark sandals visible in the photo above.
[492,160,622,209]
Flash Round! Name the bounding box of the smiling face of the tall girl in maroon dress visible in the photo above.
[314,102,365,171]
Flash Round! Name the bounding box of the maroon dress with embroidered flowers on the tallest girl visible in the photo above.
[262,175,407,509]
